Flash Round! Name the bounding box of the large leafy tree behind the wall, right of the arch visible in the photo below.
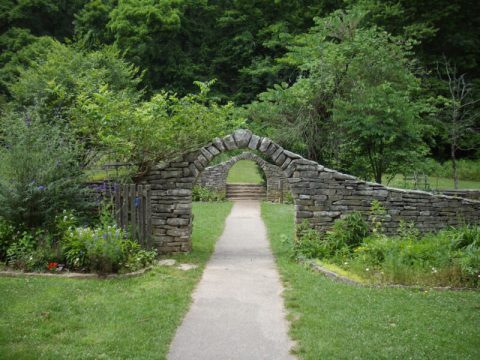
[250,10,430,182]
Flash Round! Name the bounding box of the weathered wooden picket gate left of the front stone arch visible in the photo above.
[113,184,152,249]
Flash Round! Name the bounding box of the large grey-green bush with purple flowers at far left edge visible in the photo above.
[0,114,86,229]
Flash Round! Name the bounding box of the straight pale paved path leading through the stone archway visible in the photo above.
[168,201,294,360]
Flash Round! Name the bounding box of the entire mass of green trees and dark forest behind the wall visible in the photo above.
[0,0,480,182]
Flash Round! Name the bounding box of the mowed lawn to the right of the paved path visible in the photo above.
[262,203,480,360]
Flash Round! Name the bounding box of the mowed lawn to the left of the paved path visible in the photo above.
[0,202,231,360]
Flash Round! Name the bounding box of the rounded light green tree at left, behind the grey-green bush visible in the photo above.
[9,40,142,166]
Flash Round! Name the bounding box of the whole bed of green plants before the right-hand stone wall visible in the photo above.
[293,203,480,287]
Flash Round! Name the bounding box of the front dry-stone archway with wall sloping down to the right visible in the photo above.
[141,129,480,253]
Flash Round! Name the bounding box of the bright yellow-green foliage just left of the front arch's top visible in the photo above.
[75,82,242,172]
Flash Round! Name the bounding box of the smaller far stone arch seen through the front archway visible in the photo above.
[197,152,290,202]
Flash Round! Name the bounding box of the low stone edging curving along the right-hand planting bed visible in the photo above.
[301,260,480,291]
